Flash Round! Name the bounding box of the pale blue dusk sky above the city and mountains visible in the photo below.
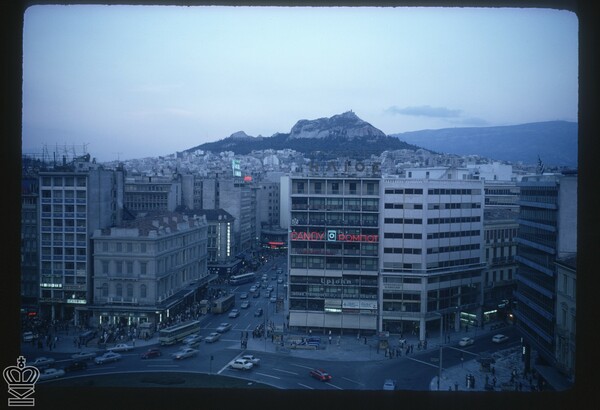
[22,5,578,162]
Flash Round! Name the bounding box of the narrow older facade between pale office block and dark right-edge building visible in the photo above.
[483,210,519,323]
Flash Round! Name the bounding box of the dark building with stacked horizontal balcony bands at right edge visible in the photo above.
[515,174,577,378]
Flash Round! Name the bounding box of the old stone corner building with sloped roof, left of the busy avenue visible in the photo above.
[91,213,208,325]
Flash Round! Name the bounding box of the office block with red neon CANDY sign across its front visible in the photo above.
[281,166,381,333]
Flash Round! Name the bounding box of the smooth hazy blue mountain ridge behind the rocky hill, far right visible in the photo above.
[392,121,578,168]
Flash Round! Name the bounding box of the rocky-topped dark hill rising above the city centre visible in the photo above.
[187,111,419,160]
